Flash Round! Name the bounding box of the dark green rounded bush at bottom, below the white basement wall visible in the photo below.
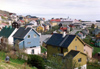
[27,55,45,69]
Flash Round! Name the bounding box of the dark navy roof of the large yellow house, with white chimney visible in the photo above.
[46,33,76,48]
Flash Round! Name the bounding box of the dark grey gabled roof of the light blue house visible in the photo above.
[13,27,39,39]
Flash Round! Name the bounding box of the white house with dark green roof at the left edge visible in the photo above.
[0,26,17,45]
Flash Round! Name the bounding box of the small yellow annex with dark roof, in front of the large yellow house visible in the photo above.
[64,50,87,69]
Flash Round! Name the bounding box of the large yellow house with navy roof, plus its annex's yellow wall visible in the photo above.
[46,34,87,68]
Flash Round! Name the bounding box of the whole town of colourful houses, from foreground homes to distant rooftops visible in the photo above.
[0,13,100,69]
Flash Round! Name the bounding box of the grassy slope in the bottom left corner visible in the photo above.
[0,51,37,69]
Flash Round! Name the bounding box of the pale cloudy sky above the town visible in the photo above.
[0,0,100,21]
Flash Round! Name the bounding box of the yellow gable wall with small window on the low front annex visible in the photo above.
[73,53,87,68]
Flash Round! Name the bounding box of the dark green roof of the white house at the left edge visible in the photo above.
[0,27,15,38]
